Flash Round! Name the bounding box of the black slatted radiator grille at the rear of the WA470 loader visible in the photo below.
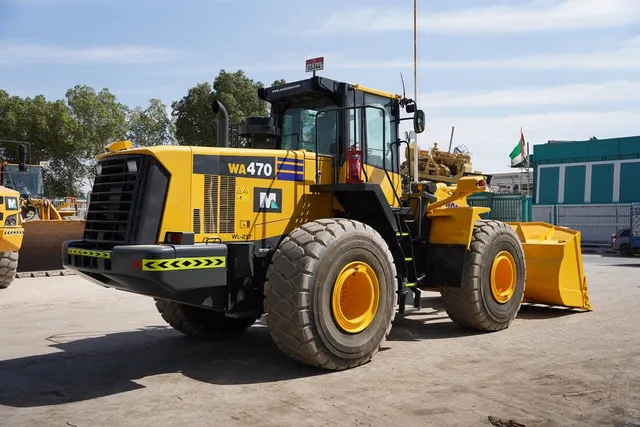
[83,156,142,244]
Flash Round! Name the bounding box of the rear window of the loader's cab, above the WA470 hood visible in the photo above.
[280,94,338,155]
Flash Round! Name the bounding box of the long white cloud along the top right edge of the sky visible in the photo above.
[307,0,640,34]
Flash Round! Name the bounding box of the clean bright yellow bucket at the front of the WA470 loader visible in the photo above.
[509,222,591,310]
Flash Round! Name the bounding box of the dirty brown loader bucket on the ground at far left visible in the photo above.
[18,219,85,272]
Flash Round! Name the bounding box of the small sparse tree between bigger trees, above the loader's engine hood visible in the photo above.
[126,98,175,147]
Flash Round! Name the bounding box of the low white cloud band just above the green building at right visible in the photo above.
[402,110,640,173]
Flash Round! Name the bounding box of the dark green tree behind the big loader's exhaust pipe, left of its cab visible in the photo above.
[171,69,284,146]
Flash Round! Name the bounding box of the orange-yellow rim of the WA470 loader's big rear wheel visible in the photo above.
[331,261,380,334]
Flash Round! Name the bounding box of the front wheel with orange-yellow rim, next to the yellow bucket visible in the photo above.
[441,220,526,331]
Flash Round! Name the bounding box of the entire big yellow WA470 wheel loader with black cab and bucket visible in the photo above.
[63,76,591,370]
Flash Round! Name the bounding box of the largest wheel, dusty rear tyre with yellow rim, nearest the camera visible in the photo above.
[264,219,397,370]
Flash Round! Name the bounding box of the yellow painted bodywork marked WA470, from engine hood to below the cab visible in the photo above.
[99,146,401,246]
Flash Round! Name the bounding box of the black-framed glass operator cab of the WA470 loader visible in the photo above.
[258,76,424,180]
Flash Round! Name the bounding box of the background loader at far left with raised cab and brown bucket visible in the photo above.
[0,143,84,272]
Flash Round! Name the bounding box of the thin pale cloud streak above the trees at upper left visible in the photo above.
[0,41,179,65]
